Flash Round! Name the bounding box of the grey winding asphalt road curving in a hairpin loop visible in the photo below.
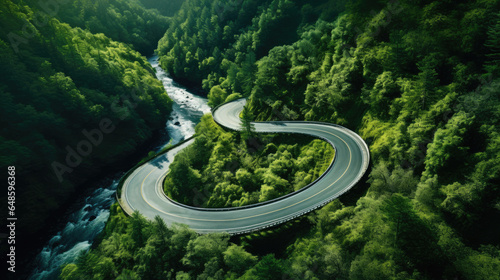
[119,99,370,235]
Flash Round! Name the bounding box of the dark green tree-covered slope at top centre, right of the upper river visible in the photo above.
[158,0,345,91]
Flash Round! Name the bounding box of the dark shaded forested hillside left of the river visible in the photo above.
[0,1,171,249]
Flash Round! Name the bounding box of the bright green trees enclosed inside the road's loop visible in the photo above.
[165,114,334,207]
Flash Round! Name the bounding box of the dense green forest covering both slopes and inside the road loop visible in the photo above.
[0,0,500,280]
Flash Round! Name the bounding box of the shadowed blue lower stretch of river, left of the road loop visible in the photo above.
[26,131,168,279]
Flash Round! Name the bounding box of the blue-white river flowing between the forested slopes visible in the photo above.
[29,56,210,280]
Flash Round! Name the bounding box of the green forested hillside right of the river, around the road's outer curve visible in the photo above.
[62,0,500,279]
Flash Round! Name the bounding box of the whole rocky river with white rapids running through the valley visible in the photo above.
[23,56,210,279]
